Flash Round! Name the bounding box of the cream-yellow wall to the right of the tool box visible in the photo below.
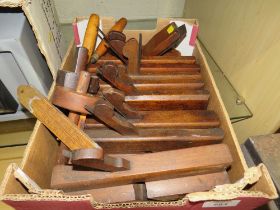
[185,0,280,142]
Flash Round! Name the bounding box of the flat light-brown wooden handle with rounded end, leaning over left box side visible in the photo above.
[17,85,102,150]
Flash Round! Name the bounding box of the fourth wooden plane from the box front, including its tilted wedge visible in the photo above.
[86,88,220,128]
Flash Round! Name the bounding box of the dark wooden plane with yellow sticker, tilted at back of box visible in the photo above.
[142,22,186,55]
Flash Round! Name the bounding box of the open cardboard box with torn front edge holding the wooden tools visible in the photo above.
[0,13,277,210]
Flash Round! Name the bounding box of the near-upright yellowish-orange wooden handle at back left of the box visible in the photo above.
[83,14,99,62]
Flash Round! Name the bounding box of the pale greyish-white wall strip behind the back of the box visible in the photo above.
[54,0,185,23]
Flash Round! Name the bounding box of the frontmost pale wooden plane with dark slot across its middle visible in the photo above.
[67,171,230,203]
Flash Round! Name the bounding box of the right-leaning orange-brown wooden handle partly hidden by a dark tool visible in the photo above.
[91,18,127,63]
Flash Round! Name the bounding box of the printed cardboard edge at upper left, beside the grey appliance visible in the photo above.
[0,0,66,77]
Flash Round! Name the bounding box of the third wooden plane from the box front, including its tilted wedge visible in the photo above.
[83,103,224,153]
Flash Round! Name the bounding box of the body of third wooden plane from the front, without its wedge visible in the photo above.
[85,128,224,154]
